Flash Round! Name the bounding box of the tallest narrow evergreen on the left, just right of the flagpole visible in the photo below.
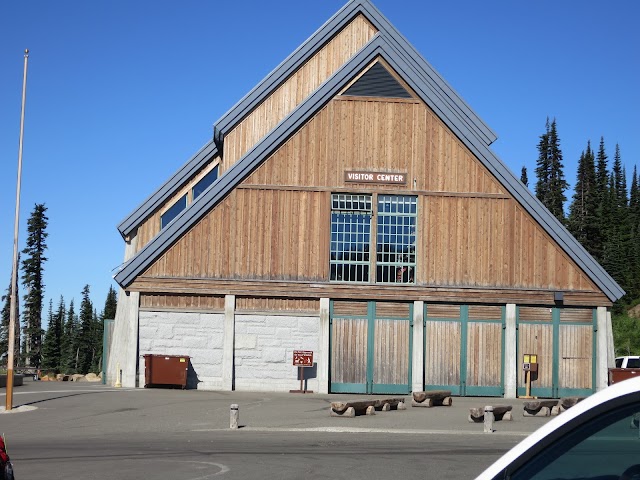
[22,204,49,367]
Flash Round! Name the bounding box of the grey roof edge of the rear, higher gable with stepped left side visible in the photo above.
[118,0,497,238]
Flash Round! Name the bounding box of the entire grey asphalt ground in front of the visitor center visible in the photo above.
[0,379,549,480]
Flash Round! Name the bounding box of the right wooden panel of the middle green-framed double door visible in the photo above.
[466,322,502,387]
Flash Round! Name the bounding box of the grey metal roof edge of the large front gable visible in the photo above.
[114,34,624,301]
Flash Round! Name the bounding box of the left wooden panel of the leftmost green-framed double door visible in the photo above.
[331,317,368,383]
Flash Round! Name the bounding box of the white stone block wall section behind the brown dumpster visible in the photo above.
[138,311,224,390]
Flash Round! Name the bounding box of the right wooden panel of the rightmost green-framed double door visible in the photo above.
[558,325,593,389]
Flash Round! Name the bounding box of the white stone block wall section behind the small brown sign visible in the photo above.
[234,315,318,392]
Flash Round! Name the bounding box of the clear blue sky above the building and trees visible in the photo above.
[0,0,640,318]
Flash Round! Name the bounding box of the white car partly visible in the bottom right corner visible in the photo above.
[476,377,640,480]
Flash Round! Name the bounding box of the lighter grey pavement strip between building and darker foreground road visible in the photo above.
[0,380,550,437]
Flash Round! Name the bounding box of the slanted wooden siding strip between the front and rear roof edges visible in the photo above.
[223,15,377,170]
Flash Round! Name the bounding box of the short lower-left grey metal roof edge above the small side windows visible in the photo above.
[118,140,218,238]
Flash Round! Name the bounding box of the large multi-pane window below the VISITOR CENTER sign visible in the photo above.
[330,193,418,284]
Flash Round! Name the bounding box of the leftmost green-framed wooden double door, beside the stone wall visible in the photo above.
[330,301,413,394]
